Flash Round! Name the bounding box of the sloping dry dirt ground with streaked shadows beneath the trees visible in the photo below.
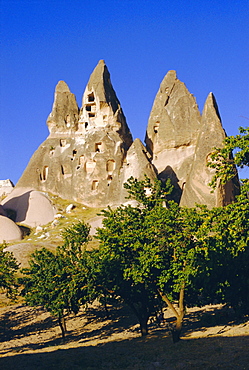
[0,304,249,370]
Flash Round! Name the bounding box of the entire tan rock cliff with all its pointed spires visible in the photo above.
[17,60,239,207]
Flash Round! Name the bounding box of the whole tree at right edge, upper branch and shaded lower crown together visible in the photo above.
[203,127,249,313]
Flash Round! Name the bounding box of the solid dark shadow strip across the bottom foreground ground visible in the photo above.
[0,335,249,370]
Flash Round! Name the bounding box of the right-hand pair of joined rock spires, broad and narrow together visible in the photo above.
[145,71,238,207]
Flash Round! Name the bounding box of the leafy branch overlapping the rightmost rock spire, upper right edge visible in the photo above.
[208,127,249,191]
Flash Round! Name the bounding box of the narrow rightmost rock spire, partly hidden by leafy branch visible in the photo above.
[180,93,239,207]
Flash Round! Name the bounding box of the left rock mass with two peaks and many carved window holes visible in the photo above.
[14,60,156,207]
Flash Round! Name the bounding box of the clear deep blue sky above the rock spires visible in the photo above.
[0,0,249,183]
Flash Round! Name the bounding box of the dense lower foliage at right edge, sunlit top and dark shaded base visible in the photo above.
[195,195,249,313]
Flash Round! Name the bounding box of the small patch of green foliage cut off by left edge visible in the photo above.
[0,243,18,298]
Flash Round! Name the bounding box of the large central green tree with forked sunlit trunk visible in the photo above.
[97,178,206,341]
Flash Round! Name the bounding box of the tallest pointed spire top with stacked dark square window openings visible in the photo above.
[79,60,132,148]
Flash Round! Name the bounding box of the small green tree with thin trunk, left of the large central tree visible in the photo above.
[21,222,94,338]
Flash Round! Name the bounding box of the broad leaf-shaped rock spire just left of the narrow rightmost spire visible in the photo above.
[145,71,201,201]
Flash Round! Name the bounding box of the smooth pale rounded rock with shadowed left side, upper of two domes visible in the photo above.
[2,187,55,227]
